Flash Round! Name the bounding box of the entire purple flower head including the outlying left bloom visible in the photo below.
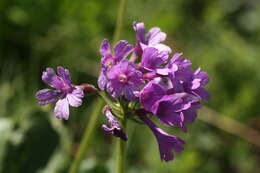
[36,23,209,161]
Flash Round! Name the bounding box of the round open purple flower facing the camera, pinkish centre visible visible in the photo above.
[107,59,144,101]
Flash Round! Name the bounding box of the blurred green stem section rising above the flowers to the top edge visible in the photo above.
[113,0,126,44]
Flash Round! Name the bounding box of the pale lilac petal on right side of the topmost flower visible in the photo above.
[147,27,166,44]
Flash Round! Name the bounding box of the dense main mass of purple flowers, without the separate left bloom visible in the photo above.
[98,23,209,161]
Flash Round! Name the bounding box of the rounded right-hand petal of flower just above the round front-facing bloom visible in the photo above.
[114,40,133,61]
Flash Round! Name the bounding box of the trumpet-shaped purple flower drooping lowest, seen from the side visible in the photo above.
[140,115,185,162]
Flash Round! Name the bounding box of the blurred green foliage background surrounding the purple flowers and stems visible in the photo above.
[0,0,260,173]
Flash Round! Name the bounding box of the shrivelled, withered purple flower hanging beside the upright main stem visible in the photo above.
[101,105,128,141]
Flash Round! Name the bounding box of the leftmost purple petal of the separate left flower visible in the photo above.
[35,89,62,105]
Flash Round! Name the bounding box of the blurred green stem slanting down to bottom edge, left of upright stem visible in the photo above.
[69,98,104,173]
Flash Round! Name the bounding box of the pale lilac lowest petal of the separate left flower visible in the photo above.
[54,97,69,120]
